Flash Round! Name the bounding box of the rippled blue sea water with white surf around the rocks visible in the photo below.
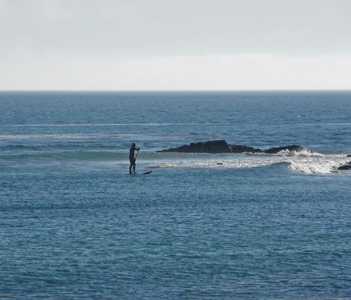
[0,91,351,299]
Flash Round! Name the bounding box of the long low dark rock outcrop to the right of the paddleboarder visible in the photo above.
[157,140,305,154]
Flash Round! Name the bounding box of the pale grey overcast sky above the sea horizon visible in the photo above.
[0,0,351,91]
